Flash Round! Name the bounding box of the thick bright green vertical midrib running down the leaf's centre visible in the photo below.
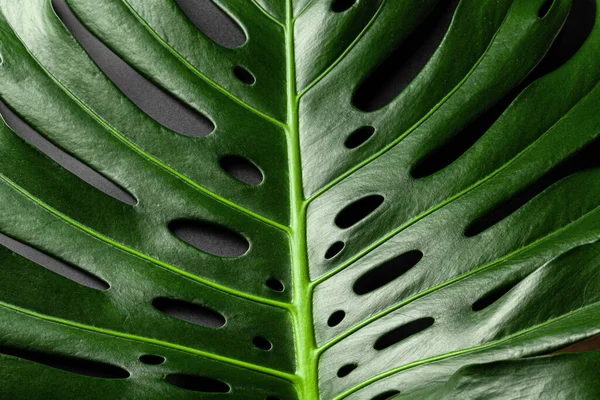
[285,0,319,400]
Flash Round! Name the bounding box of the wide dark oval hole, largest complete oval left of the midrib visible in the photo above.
[169,219,250,257]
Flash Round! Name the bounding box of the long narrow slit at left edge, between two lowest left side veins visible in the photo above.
[0,233,110,290]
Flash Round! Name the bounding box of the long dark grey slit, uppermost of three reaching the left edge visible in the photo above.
[0,100,137,205]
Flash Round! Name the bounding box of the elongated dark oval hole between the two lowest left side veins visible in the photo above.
[152,297,226,329]
